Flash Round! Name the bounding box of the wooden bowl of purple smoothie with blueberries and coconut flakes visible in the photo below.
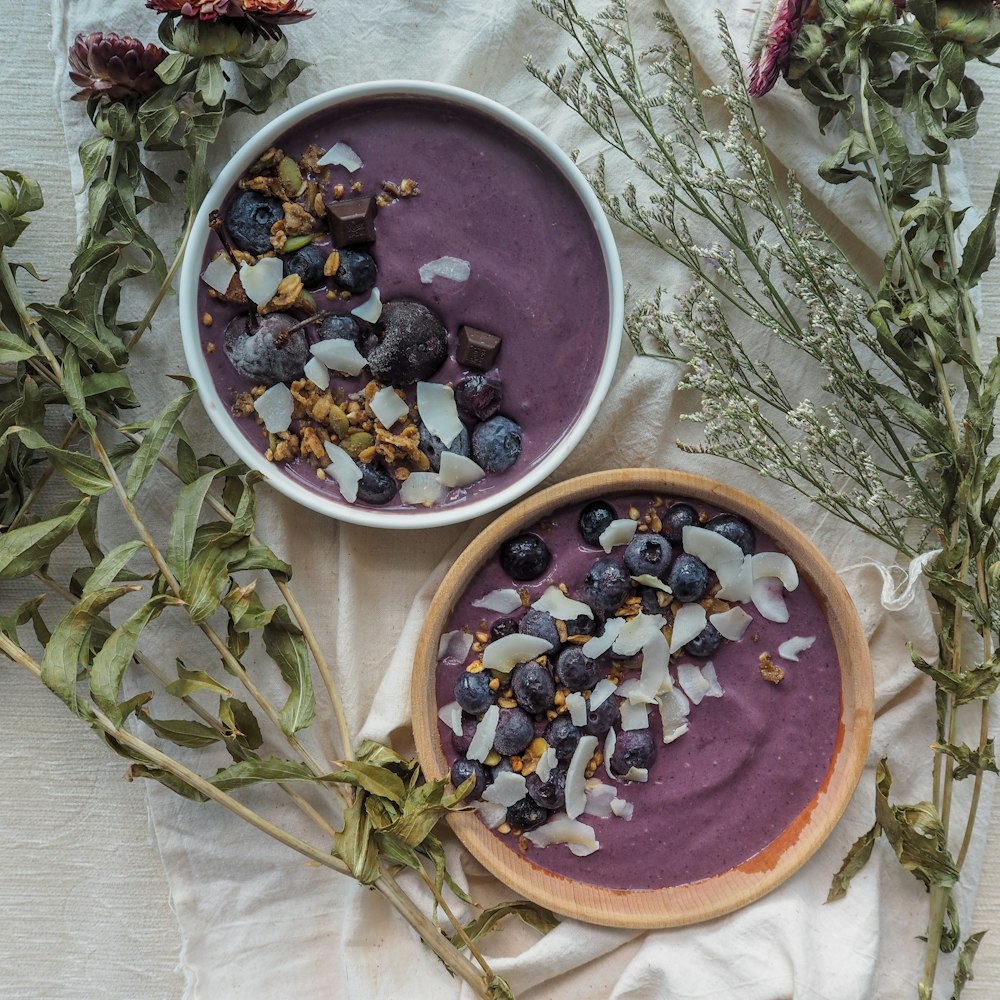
[412,470,872,927]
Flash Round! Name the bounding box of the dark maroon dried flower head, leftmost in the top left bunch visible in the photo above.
[69,31,167,101]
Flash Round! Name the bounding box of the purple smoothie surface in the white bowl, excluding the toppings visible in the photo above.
[198,96,610,511]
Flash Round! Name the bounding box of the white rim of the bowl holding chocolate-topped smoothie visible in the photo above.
[179,80,625,528]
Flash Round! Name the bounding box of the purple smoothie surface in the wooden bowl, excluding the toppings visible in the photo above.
[436,494,841,889]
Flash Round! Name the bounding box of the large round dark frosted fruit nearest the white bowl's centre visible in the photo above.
[368,299,448,384]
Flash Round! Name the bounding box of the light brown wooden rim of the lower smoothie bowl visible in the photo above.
[412,469,873,928]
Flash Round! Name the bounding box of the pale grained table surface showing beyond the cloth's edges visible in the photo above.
[0,4,1000,1000]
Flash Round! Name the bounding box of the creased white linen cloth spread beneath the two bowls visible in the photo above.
[39,0,992,1000]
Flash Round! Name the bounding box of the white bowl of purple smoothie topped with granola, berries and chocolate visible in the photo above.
[180,82,623,528]
